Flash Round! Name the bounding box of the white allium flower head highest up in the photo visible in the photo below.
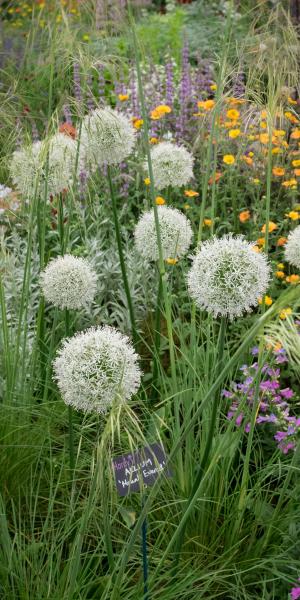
[79,108,136,171]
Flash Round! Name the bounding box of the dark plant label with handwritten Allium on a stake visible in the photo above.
[112,444,172,496]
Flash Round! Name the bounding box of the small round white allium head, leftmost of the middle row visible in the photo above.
[40,254,97,309]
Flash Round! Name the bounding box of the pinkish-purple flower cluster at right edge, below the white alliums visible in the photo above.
[223,348,300,454]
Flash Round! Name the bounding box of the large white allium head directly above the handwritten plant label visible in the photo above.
[53,325,141,413]
